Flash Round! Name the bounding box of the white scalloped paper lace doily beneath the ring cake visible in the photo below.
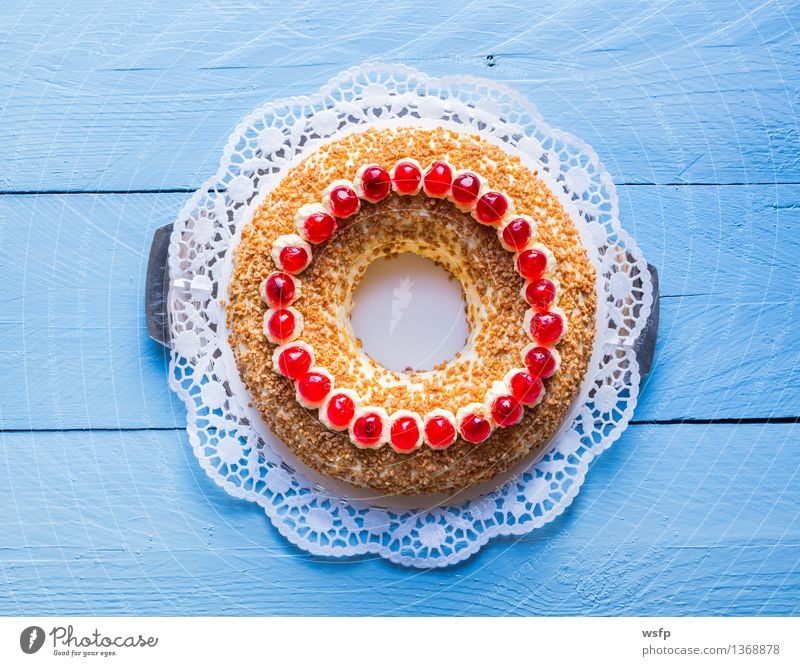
[168,65,652,567]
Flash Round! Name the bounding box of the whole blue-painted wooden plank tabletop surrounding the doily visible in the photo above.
[0,0,800,615]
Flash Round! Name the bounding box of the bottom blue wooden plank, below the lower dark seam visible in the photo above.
[0,425,800,615]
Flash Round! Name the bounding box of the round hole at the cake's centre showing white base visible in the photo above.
[352,252,469,372]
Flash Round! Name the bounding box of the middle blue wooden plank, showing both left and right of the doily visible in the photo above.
[0,186,800,429]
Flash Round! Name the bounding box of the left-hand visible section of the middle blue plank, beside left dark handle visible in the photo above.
[0,195,186,429]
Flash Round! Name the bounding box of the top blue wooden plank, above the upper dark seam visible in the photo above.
[0,0,800,191]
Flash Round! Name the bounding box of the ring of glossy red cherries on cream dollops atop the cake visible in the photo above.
[260,158,566,453]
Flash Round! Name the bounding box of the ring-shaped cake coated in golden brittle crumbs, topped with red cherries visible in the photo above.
[227,128,597,495]
